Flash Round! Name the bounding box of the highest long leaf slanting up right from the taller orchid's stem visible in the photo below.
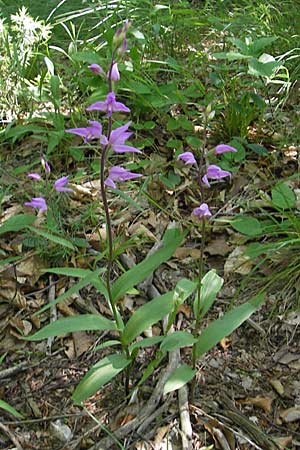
[111,228,184,302]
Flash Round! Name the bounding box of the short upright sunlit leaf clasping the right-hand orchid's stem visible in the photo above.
[194,269,224,317]
